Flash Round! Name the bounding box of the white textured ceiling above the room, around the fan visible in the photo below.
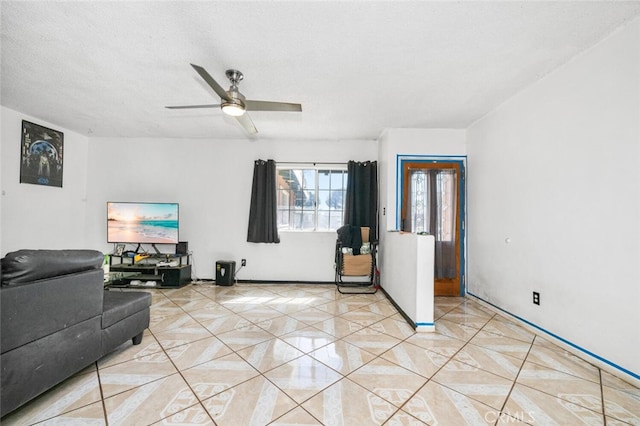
[0,1,640,139]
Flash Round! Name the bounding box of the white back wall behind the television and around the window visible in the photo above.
[86,138,378,281]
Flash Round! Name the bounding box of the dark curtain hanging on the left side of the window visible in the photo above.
[247,160,280,243]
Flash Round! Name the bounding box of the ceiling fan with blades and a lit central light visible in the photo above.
[165,64,302,134]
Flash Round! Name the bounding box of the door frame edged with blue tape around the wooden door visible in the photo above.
[396,154,467,296]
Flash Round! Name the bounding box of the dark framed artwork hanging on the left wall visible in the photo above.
[20,120,64,188]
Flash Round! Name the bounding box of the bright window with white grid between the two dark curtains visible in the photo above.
[276,165,347,231]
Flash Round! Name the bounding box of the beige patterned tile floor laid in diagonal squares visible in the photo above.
[2,284,640,426]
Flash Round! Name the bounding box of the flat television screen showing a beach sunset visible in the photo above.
[107,202,179,244]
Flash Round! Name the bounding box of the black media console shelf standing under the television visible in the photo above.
[109,254,191,288]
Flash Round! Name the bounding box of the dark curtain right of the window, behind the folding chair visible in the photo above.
[344,161,378,241]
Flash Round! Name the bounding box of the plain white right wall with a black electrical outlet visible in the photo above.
[467,19,640,378]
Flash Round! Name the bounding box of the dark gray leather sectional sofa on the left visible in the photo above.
[0,250,151,416]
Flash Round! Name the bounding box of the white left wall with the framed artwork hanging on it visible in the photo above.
[0,107,94,256]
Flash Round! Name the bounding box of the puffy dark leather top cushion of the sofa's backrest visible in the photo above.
[2,250,104,286]
